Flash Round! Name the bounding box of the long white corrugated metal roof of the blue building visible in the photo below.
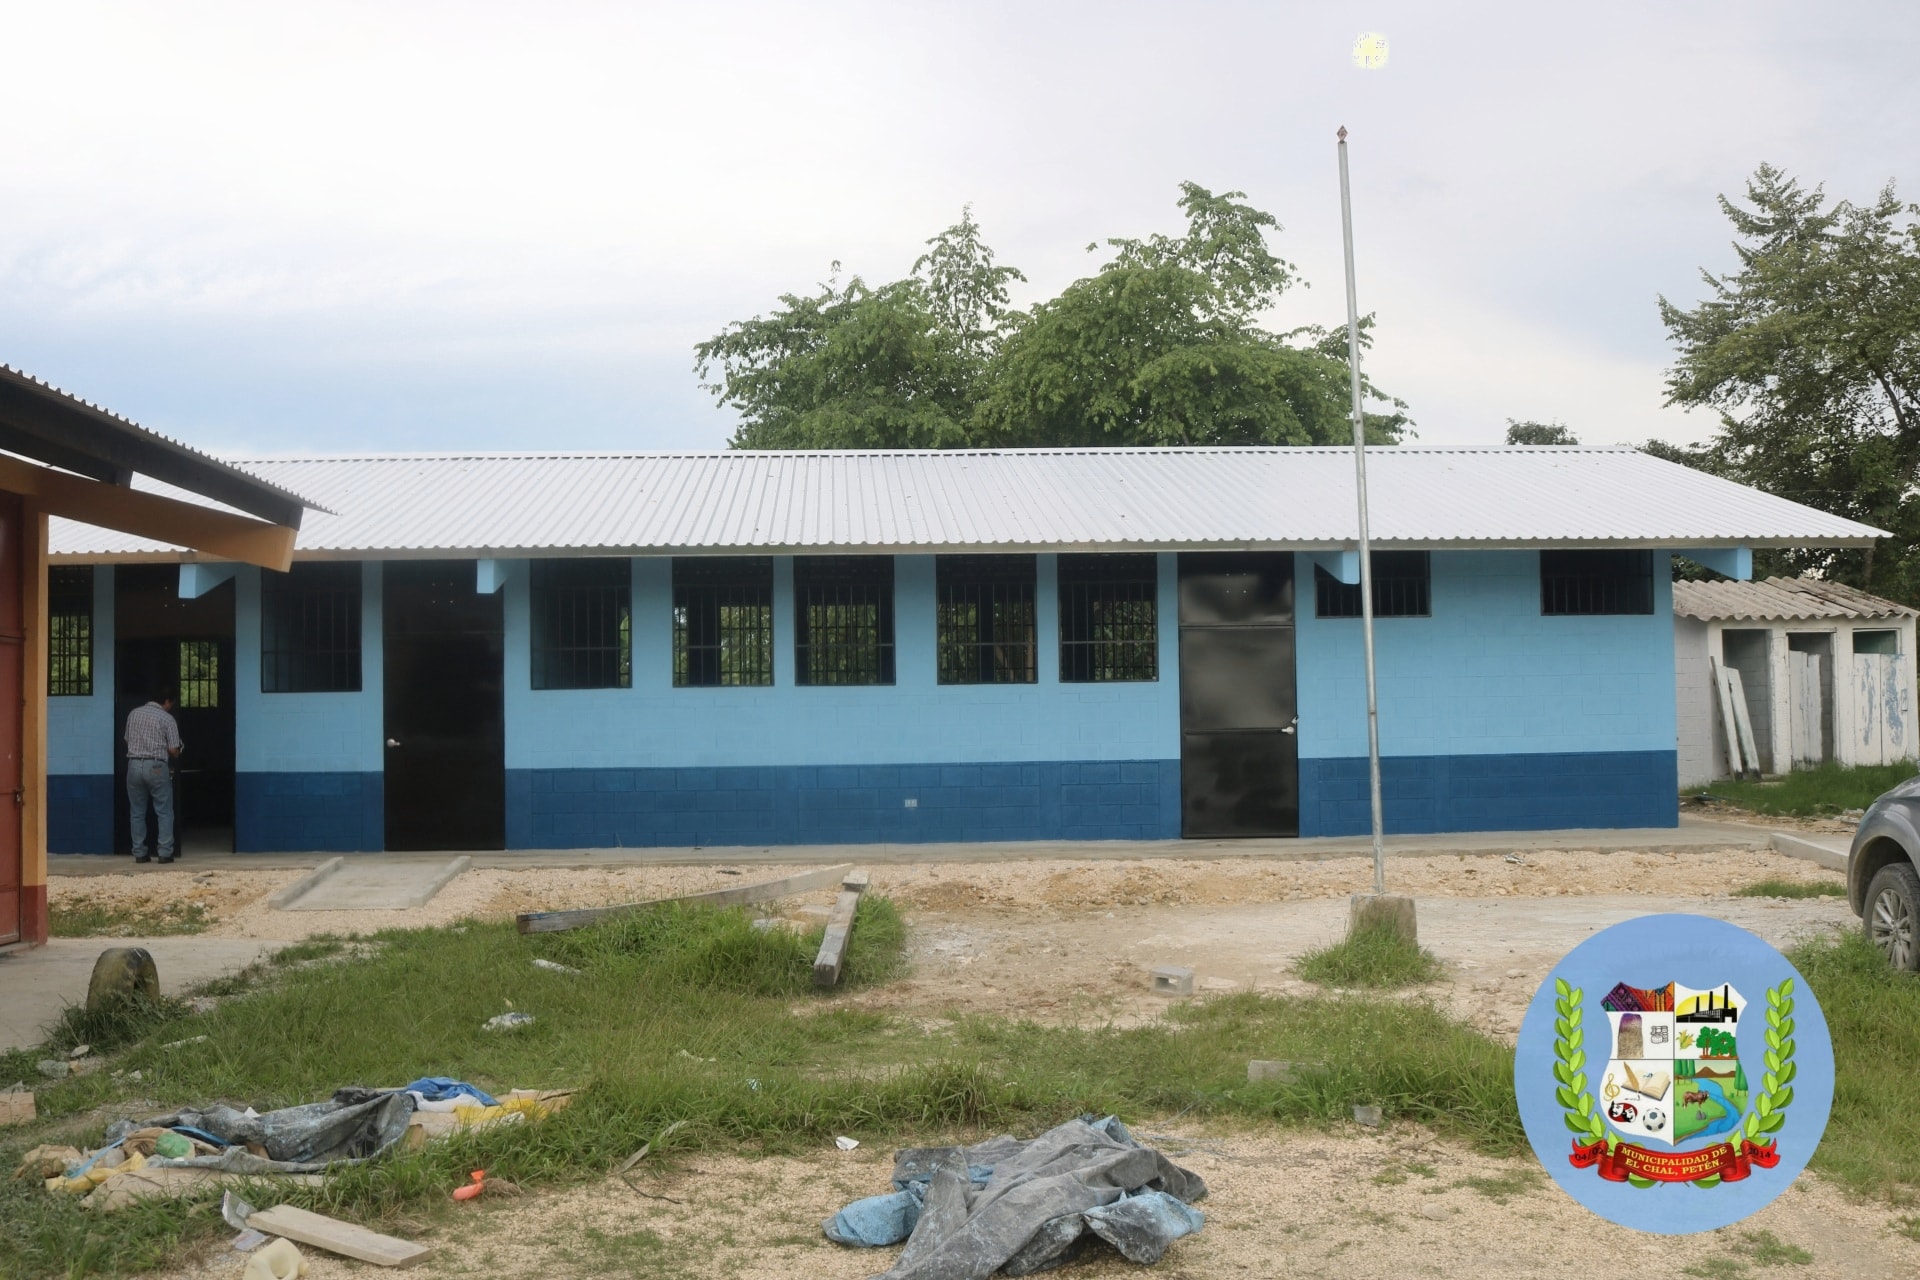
[52,445,1882,558]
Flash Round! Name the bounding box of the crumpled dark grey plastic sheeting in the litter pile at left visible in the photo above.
[108,1088,413,1173]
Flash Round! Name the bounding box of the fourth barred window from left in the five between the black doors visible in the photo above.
[933,555,1037,685]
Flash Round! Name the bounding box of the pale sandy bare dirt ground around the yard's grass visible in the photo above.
[54,850,1920,1280]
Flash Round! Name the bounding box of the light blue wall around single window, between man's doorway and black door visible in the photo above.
[234,562,386,773]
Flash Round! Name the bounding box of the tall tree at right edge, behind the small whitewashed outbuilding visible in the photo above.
[1649,165,1920,603]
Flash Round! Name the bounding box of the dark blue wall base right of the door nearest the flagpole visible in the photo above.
[1300,750,1680,835]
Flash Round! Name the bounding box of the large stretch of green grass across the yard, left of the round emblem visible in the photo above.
[0,896,1526,1278]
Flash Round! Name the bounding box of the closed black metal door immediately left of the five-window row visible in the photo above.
[382,560,507,850]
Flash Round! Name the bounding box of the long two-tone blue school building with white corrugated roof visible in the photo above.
[48,447,1880,854]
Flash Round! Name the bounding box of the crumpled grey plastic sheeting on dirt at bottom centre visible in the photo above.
[828,1117,1206,1280]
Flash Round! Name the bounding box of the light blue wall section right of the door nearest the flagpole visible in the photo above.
[1294,551,1676,760]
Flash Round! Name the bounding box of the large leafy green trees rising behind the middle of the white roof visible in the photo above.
[695,182,1409,449]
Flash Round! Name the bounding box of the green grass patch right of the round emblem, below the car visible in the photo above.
[1788,929,1920,1203]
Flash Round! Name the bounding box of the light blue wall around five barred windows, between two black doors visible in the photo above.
[503,555,1179,770]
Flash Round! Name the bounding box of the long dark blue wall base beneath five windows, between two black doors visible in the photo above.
[507,760,1181,848]
